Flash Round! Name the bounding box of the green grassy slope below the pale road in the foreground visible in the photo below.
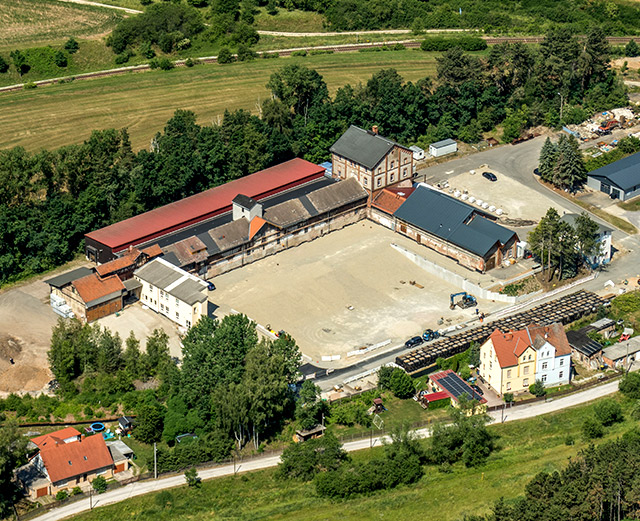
[65,394,636,521]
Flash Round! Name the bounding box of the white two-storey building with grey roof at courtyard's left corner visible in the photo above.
[133,258,208,329]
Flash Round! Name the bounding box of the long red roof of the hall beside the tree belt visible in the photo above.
[86,158,324,251]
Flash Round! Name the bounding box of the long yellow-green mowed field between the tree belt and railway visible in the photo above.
[0,50,437,150]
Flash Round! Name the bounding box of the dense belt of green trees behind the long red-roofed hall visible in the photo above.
[0,29,627,284]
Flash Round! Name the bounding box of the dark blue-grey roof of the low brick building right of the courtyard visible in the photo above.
[393,185,517,257]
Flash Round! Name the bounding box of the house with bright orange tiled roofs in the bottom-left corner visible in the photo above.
[16,427,114,499]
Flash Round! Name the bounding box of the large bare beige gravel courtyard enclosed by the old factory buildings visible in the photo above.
[210,221,501,365]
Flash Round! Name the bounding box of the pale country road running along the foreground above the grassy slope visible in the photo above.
[35,380,618,521]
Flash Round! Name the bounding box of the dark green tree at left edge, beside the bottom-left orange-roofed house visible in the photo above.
[0,419,28,519]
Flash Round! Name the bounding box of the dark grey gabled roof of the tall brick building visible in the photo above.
[330,125,409,170]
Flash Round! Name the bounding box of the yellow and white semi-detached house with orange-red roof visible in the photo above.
[478,323,571,395]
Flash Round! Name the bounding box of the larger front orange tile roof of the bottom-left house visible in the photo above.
[37,433,113,483]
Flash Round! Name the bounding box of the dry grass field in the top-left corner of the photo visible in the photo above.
[0,0,123,51]
